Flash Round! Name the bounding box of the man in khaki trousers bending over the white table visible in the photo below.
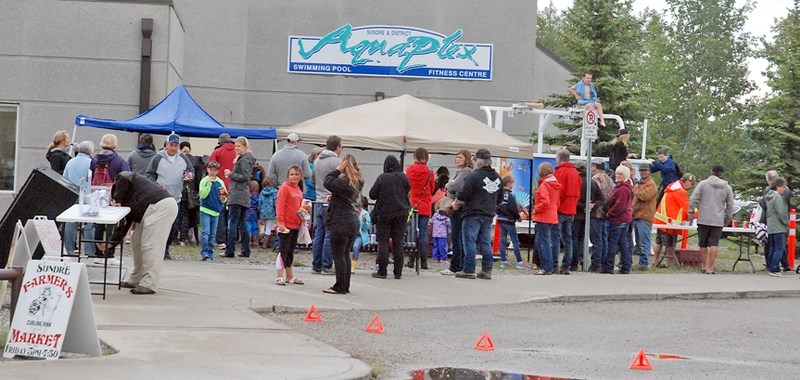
[111,172,178,294]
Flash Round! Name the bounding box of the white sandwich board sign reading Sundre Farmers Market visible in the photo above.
[3,257,100,359]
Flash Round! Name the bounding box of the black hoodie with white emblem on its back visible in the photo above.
[456,166,503,218]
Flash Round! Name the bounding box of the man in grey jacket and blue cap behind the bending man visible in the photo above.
[145,133,194,260]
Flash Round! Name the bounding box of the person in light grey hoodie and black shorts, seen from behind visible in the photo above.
[689,165,733,274]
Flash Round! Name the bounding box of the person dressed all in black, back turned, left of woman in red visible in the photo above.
[369,155,411,279]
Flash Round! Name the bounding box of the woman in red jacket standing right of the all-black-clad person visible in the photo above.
[406,147,436,269]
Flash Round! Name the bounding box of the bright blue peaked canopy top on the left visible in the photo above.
[75,85,275,139]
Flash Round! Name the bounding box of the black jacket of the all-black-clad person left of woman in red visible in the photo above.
[369,155,411,224]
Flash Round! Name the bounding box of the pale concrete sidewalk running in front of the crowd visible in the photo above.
[0,258,800,380]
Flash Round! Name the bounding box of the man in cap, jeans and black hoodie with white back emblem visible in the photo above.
[453,149,503,280]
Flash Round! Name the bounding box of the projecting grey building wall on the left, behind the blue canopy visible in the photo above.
[0,0,183,210]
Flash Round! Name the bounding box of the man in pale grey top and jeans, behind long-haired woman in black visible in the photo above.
[311,135,343,274]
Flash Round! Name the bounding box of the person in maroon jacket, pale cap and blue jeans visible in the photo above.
[603,165,644,274]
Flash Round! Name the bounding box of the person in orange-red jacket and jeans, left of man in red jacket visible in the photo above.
[533,162,561,275]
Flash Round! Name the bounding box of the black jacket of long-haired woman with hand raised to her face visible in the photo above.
[324,169,364,236]
